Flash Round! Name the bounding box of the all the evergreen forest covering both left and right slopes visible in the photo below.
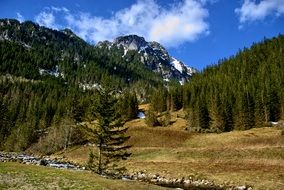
[0,17,284,154]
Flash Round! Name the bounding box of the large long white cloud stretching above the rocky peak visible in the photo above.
[36,0,210,47]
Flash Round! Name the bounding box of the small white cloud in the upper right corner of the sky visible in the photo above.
[235,0,284,28]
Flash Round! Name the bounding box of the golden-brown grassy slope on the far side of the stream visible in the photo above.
[57,112,284,189]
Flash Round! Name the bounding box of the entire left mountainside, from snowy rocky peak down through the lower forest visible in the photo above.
[0,19,196,153]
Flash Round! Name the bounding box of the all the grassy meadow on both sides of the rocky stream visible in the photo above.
[0,111,284,189]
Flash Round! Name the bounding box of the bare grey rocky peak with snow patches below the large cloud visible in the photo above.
[96,35,197,84]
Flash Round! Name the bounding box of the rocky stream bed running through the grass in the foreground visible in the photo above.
[0,152,252,190]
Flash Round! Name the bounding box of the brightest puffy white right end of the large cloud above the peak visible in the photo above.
[149,1,208,45]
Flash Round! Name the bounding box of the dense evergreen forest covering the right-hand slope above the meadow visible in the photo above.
[151,35,284,132]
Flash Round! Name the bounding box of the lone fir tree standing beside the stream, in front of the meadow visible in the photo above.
[88,89,131,174]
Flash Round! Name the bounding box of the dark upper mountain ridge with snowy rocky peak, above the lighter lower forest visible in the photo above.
[0,19,196,88]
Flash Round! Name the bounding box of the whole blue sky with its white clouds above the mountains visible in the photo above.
[0,0,284,71]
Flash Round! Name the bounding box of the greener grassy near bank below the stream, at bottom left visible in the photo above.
[0,163,169,190]
